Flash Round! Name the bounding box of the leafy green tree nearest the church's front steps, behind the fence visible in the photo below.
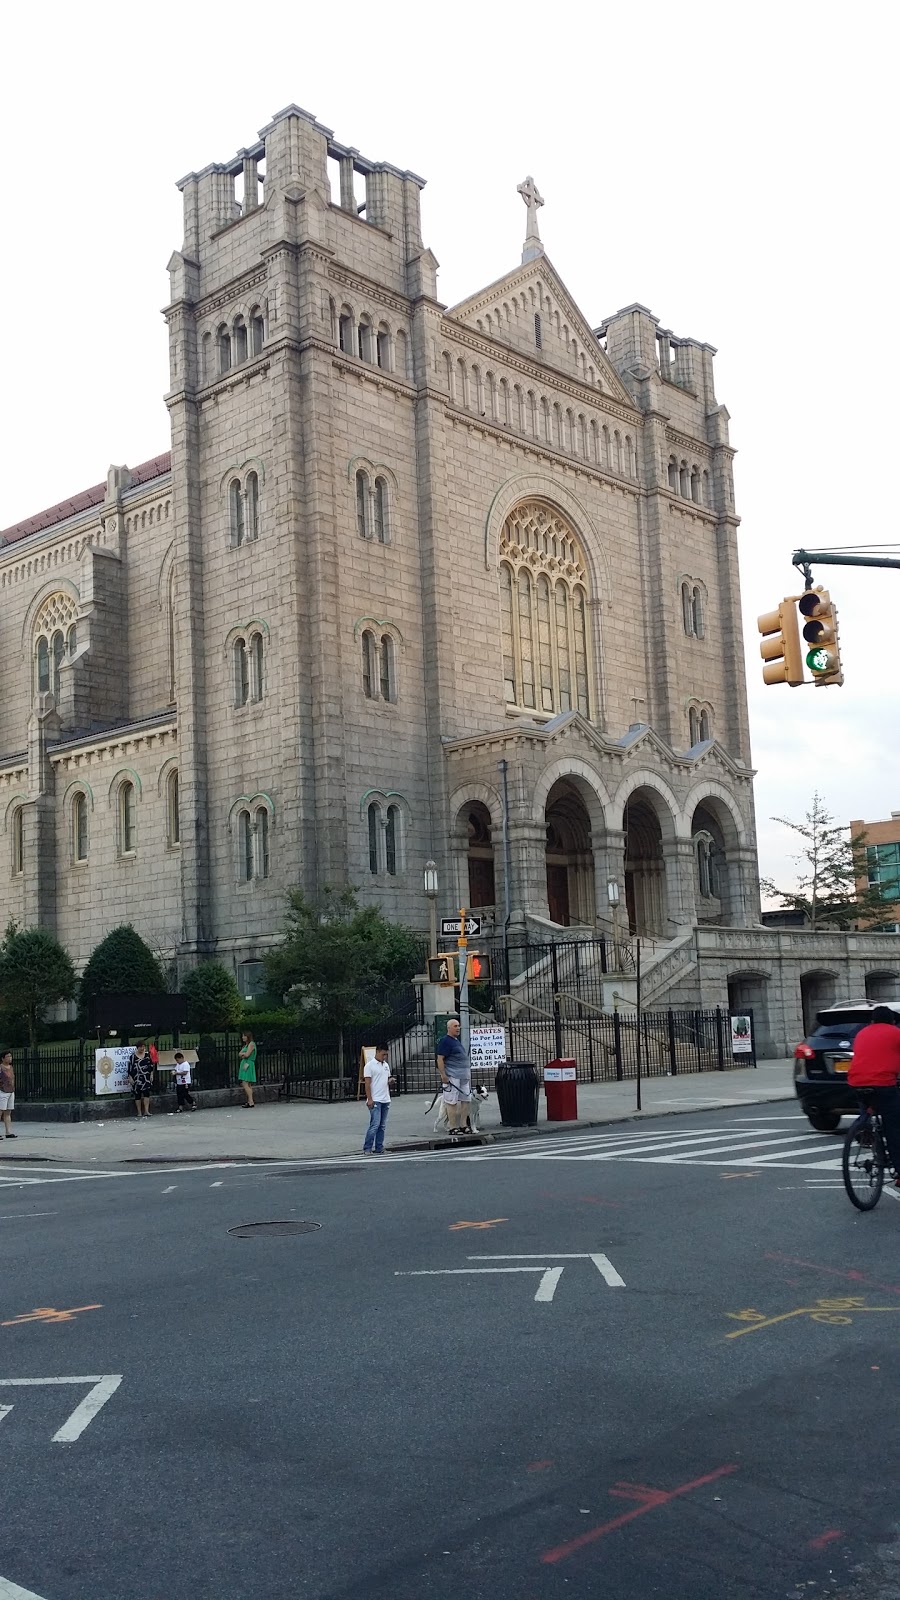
[264,888,423,1059]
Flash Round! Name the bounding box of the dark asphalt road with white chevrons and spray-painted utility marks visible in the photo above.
[0,1104,900,1600]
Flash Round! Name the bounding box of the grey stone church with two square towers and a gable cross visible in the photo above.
[8,106,890,1049]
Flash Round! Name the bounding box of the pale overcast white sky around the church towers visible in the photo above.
[0,0,900,878]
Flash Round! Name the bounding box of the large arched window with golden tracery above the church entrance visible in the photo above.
[500,501,593,717]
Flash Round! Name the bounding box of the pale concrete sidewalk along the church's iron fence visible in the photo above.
[0,1061,796,1166]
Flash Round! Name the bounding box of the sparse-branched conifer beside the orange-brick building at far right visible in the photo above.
[759,792,894,931]
